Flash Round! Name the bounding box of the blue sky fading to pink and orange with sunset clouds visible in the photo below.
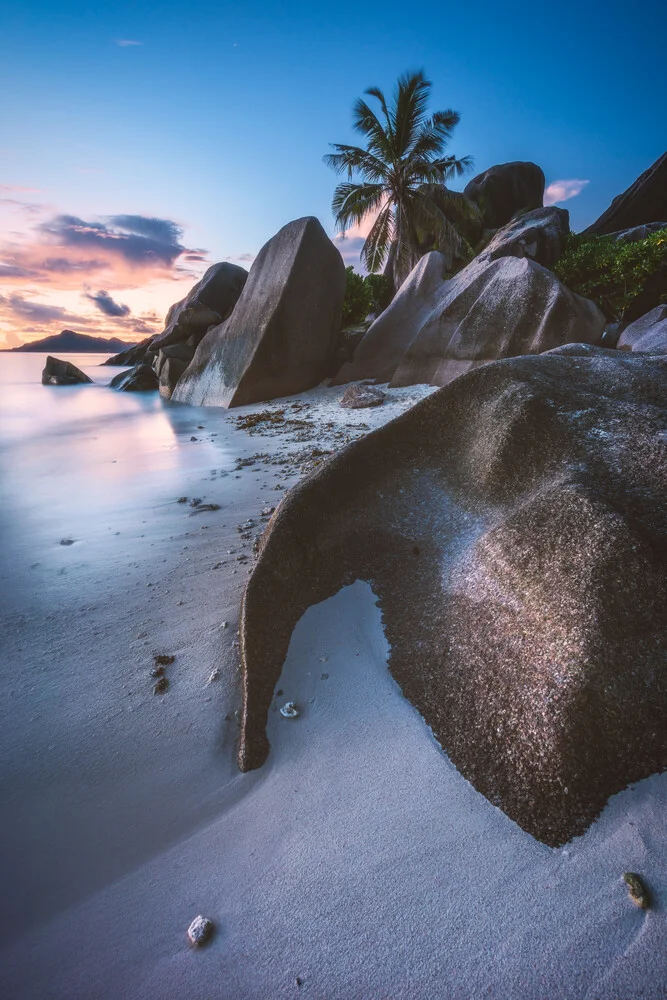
[0,0,667,347]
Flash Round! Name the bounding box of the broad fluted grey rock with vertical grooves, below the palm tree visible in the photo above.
[335,240,605,386]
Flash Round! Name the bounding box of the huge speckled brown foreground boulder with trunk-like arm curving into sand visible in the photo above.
[239,345,667,846]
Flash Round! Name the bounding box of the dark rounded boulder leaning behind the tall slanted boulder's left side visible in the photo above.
[151,261,248,351]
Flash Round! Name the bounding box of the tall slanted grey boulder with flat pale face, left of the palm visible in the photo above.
[172,217,345,406]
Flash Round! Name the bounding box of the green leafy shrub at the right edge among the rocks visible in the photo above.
[553,229,667,320]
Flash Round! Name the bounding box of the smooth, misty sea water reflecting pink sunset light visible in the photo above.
[0,353,235,532]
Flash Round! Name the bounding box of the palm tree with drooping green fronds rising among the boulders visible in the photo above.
[324,70,481,288]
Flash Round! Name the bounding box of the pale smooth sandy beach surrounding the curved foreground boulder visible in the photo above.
[0,356,667,1000]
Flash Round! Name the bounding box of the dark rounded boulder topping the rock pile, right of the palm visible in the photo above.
[463,161,545,229]
